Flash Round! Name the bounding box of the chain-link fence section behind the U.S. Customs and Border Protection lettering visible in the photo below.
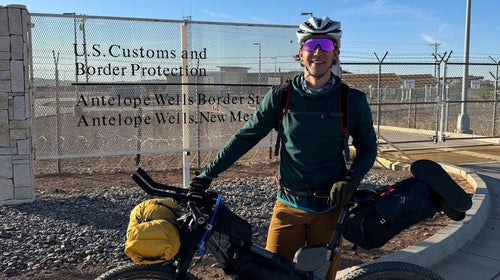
[32,14,298,173]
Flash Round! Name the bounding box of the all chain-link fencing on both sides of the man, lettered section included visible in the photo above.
[32,14,500,175]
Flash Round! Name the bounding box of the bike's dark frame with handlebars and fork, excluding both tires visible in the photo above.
[132,168,347,279]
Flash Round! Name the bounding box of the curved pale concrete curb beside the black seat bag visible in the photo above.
[337,164,490,277]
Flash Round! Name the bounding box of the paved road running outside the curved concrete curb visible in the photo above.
[381,131,500,280]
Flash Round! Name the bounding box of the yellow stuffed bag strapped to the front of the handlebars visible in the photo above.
[125,198,181,264]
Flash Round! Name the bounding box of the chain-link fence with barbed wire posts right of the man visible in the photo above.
[343,61,500,144]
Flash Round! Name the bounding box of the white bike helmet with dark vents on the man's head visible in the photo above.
[297,17,342,48]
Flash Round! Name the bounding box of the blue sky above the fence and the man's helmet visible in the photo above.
[0,0,500,62]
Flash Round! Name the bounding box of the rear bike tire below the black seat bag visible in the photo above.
[341,261,445,280]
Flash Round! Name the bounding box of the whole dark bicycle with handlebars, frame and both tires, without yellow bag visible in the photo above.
[97,168,444,280]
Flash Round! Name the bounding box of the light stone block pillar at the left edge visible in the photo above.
[0,5,35,205]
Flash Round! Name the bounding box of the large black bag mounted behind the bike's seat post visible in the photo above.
[342,177,440,250]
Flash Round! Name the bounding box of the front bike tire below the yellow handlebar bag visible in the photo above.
[96,263,198,280]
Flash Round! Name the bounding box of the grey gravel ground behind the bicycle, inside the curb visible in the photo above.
[0,174,418,279]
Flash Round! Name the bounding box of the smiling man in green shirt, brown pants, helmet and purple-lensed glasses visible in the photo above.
[191,17,377,279]
